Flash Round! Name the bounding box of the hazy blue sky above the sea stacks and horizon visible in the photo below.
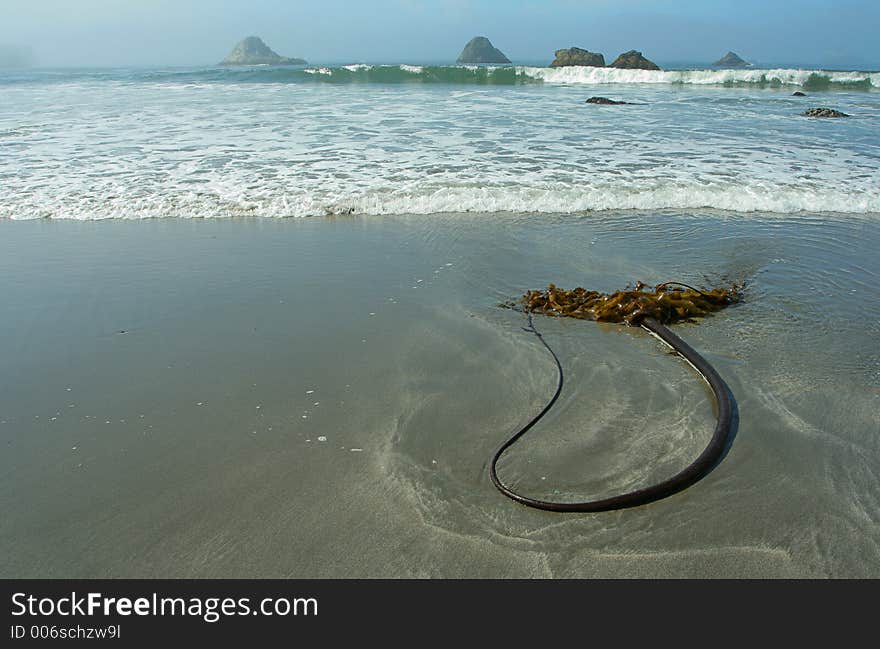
[0,0,880,69]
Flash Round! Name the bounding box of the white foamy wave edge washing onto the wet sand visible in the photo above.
[6,183,880,220]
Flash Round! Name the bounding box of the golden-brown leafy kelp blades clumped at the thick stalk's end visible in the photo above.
[505,282,743,326]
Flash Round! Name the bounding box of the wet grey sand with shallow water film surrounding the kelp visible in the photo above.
[0,212,880,577]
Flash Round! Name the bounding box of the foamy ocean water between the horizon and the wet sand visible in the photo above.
[0,65,880,219]
